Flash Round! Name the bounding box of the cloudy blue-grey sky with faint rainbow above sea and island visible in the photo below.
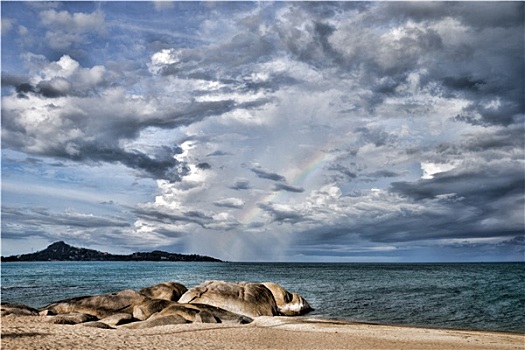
[1,1,525,262]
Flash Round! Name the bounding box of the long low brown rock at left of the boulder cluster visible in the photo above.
[41,289,148,318]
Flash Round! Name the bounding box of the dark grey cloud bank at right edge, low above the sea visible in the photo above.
[362,166,525,242]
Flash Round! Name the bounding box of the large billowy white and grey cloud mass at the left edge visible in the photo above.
[2,55,246,181]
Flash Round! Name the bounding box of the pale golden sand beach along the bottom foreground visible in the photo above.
[1,315,525,350]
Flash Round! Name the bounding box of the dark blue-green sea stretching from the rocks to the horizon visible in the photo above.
[1,262,525,333]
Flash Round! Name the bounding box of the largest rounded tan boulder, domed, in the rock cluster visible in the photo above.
[179,281,278,317]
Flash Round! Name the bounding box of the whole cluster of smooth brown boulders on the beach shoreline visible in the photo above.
[2,281,312,329]
